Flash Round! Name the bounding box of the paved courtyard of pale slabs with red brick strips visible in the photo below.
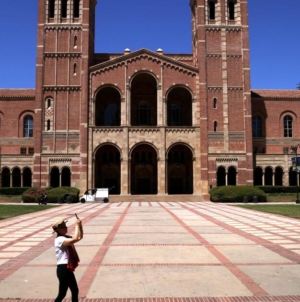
[0,197,300,302]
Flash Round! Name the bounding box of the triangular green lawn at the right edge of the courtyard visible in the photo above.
[234,204,300,219]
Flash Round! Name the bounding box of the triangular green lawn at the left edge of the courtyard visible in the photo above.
[0,204,53,220]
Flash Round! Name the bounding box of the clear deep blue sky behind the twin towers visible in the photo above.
[0,0,300,89]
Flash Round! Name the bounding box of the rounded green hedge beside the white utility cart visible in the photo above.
[22,187,80,203]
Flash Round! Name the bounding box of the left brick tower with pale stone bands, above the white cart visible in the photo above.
[33,0,96,188]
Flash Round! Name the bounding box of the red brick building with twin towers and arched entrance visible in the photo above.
[0,0,300,199]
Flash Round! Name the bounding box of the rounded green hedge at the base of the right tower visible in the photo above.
[209,186,267,202]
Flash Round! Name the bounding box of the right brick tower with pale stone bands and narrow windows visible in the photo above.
[190,0,253,192]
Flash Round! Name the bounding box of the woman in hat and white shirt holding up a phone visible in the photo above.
[52,219,83,302]
